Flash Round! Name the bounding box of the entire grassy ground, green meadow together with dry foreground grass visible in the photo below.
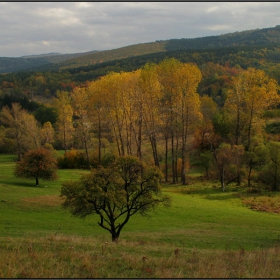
[0,155,280,278]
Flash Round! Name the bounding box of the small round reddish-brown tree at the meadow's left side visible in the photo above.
[15,148,57,186]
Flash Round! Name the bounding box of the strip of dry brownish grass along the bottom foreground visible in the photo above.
[0,235,280,278]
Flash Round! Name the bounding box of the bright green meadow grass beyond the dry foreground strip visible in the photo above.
[0,156,280,249]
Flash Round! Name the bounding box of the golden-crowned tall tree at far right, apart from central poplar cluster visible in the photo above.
[225,68,280,150]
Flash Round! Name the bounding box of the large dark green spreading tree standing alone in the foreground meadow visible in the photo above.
[61,156,170,241]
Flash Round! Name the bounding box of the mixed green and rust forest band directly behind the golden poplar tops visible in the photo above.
[0,44,280,106]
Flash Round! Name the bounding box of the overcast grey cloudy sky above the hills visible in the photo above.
[0,2,280,57]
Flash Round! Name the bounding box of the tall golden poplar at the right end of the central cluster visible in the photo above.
[158,58,202,184]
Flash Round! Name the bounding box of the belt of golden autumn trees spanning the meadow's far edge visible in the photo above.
[0,58,280,190]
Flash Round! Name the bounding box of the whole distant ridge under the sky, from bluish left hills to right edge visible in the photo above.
[0,25,280,73]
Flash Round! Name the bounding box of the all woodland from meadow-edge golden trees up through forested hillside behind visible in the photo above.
[0,27,280,190]
